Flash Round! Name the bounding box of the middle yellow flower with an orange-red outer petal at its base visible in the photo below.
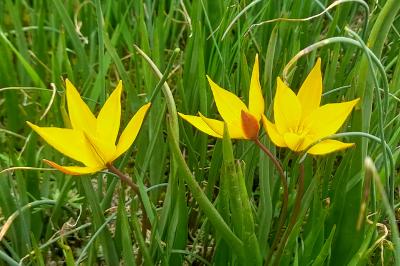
[179,55,264,139]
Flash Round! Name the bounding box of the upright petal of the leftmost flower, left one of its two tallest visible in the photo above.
[65,79,96,132]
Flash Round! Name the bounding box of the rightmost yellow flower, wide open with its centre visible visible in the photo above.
[263,59,359,155]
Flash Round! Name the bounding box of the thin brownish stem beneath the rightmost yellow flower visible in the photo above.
[273,163,304,265]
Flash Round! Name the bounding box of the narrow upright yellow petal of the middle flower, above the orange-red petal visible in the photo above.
[249,55,265,121]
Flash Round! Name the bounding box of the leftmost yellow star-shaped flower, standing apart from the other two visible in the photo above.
[27,80,150,175]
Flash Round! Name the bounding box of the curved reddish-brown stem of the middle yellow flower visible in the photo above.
[254,138,289,265]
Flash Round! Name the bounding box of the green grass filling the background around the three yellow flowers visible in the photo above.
[0,0,400,265]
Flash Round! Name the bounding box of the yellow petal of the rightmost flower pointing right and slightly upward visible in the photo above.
[304,99,359,139]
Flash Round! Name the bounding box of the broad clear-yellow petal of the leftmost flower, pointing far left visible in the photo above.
[27,122,101,166]
